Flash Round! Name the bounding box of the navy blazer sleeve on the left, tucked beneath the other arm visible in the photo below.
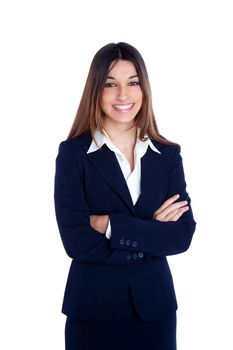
[54,141,145,264]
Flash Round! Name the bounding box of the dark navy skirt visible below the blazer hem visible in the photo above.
[65,312,176,350]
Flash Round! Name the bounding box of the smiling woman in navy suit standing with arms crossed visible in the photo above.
[54,42,196,350]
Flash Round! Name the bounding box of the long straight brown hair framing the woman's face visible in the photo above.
[67,42,177,144]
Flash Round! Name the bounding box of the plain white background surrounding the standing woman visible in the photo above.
[0,0,233,350]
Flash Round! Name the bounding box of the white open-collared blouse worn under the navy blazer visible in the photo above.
[87,129,161,239]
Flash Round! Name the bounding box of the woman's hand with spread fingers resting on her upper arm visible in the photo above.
[153,194,189,221]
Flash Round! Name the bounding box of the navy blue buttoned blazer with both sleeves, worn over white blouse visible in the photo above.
[54,134,196,321]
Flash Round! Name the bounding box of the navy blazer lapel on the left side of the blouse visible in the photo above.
[87,144,134,212]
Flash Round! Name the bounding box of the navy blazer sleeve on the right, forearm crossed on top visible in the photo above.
[110,145,196,256]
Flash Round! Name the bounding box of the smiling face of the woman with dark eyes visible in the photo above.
[100,60,142,129]
